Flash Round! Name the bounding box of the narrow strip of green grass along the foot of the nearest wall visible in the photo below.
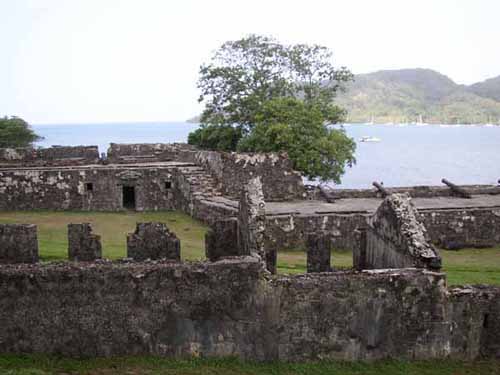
[0,355,500,375]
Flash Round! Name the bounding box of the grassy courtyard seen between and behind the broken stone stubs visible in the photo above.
[0,211,500,285]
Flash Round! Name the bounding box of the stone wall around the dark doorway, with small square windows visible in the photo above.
[0,167,179,211]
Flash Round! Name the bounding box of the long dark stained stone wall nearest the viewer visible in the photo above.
[0,257,500,361]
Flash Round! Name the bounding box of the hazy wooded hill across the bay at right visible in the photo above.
[336,69,500,124]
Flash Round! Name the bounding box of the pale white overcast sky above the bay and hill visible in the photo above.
[0,0,500,124]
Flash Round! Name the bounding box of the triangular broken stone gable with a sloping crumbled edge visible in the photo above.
[354,194,441,269]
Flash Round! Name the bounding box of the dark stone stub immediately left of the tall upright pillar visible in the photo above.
[205,218,240,262]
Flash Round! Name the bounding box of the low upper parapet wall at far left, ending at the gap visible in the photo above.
[0,146,99,168]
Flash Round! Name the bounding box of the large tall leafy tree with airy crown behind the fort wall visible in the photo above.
[188,35,354,181]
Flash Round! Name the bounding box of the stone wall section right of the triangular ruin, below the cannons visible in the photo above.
[419,207,500,249]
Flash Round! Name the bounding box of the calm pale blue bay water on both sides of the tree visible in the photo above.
[33,122,500,188]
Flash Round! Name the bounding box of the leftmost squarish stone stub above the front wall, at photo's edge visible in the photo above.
[0,224,38,263]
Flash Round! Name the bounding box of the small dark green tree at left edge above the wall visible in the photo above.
[0,117,42,148]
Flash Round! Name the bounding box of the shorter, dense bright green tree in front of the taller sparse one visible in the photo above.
[238,98,356,184]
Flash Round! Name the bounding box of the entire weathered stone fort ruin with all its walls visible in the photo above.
[0,144,500,361]
